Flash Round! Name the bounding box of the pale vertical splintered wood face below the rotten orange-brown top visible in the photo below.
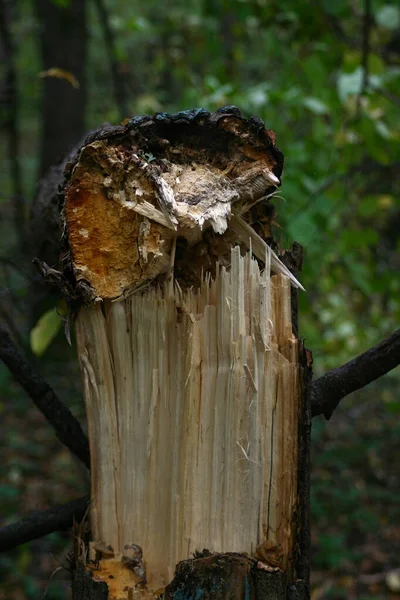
[76,247,301,589]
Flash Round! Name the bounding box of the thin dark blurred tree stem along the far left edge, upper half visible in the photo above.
[0,0,25,244]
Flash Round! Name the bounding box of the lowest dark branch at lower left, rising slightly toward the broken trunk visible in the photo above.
[0,496,89,552]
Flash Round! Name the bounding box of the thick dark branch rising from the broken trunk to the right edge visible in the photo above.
[311,329,400,419]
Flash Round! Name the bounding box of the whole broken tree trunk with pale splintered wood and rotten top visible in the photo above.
[48,107,309,600]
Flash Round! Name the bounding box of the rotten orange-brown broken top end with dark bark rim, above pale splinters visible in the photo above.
[58,107,301,301]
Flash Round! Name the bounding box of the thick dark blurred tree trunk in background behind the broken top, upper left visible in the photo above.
[35,0,88,179]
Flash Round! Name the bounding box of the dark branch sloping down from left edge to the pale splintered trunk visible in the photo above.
[0,326,90,468]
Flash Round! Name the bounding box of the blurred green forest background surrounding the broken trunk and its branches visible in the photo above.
[0,0,400,600]
